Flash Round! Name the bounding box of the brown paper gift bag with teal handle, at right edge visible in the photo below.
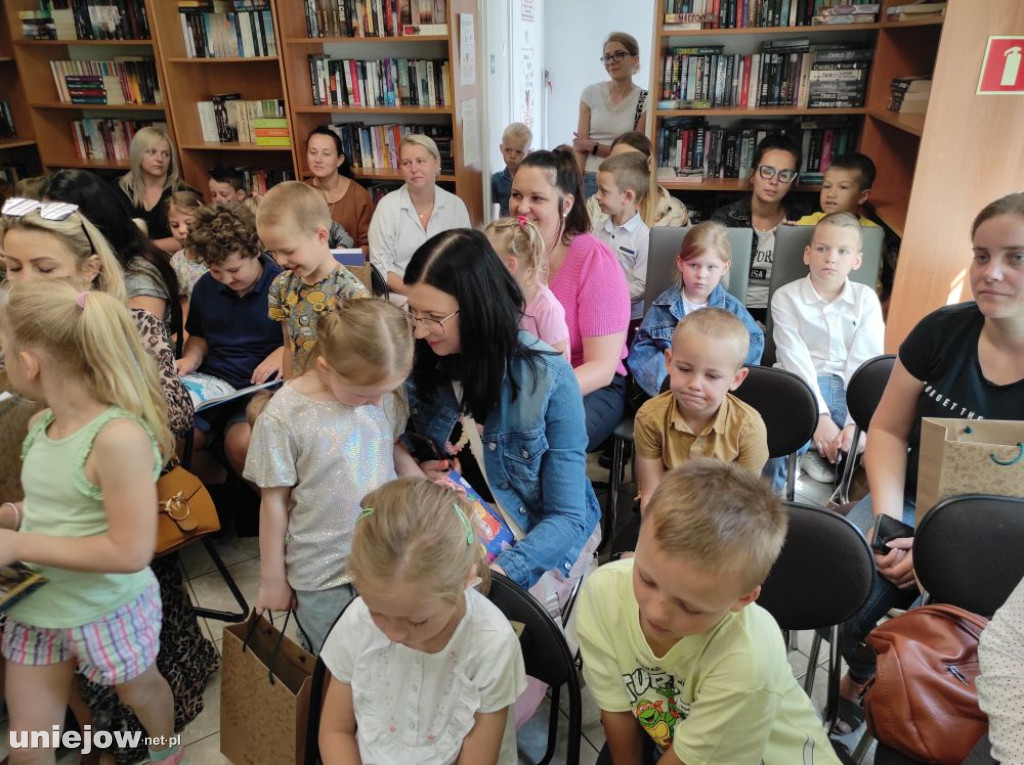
[915,417,1024,523]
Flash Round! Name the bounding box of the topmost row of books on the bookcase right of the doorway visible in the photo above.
[665,0,880,30]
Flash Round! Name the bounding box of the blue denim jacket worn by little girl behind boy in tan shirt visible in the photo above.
[626,285,765,396]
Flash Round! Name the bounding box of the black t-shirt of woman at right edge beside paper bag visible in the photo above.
[899,302,1024,499]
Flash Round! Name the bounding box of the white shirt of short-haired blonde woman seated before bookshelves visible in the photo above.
[369,185,470,278]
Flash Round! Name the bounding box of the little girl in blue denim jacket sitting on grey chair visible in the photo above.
[626,221,765,396]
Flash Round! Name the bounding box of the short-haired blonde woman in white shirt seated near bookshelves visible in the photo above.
[370,133,470,295]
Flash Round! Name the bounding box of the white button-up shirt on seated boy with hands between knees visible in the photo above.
[771,274,885,425]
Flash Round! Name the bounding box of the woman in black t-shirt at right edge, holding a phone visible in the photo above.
[841,194,1024,727]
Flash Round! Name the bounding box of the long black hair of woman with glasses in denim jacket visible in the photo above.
[404,228,541,424]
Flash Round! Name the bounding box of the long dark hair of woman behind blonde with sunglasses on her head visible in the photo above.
[43,170,181,338]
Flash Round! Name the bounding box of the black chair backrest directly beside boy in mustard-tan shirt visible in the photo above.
[733,367,818,457]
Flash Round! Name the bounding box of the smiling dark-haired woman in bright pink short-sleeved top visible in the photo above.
[509,146,630,452]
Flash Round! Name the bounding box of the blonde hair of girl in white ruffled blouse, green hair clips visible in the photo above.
[348,477,490,601]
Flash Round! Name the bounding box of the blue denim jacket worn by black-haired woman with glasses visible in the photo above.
[406,332,601,588]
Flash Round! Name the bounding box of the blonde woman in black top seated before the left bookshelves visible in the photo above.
[118,126,187,254]
